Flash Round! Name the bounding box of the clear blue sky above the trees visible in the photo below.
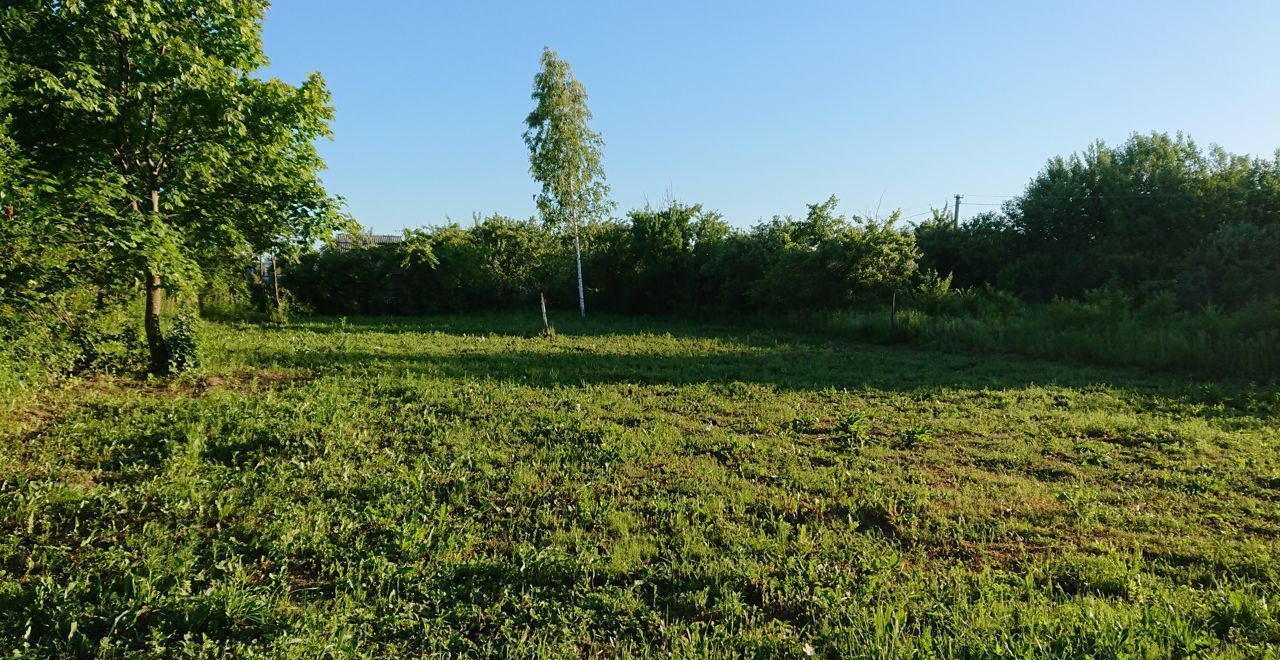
[264,0,1280,233]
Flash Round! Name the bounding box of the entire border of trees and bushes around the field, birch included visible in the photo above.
[0,0,1280,381]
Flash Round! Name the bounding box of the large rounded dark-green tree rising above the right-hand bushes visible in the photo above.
[1000,133,1280,298]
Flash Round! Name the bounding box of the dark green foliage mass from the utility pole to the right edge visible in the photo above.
[916,133,1280,307]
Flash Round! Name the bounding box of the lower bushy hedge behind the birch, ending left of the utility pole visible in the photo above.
[283,197,922,315]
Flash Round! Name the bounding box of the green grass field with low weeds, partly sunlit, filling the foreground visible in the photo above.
[0,315,1280,657]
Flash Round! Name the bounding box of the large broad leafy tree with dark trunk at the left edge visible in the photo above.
[0,0,343,372]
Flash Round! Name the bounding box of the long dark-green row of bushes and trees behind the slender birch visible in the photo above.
[284,133,1280,322]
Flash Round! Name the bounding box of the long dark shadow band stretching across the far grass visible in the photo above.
[241,335,1218,397]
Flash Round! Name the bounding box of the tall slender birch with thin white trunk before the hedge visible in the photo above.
[524,49,611,318]
